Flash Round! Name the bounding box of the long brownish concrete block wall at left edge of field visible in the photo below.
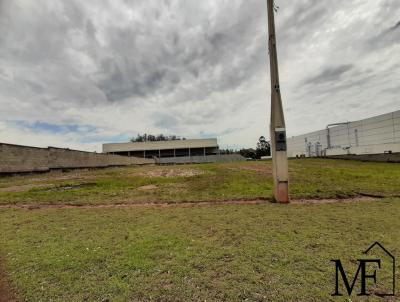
[0,143,154,173]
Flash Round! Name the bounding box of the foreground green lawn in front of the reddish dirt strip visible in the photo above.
[0,199,400,302]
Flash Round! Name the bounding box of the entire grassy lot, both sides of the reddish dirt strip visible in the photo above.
[0,160,400,301]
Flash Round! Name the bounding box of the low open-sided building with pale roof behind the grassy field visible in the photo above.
[103,138,218,158]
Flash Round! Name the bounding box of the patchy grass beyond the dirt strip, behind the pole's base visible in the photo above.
[0,159,400,204]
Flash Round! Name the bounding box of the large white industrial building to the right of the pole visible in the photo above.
[287,110,400,157]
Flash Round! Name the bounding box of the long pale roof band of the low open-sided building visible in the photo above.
[103,138,218,153]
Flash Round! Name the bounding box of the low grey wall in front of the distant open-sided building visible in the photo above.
[156,154,245,164]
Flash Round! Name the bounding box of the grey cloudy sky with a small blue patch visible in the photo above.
[0,0,400,151]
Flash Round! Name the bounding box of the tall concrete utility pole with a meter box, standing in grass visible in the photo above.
[267,0,289,203]
